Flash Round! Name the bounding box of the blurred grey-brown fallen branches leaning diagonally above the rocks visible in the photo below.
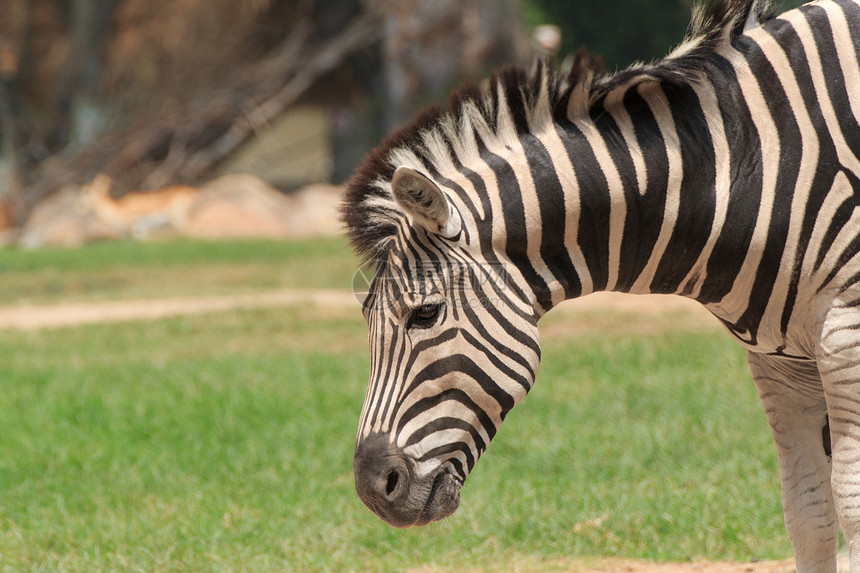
[12,7,382,219]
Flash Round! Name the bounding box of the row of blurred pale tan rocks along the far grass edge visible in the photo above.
[12,174,341,249]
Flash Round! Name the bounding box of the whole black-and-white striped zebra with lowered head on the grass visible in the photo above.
[342,0,860,572]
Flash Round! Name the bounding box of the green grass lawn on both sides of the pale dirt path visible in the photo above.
[0,237,791,572]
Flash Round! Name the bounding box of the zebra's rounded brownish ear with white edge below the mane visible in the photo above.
[391,167,463,239]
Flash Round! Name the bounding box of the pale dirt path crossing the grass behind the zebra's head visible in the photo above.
[0,289,717,330]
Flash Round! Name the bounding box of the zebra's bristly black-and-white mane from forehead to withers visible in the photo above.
[341,0,770,260]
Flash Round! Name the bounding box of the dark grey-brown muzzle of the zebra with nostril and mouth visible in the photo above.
[353,436,462,528]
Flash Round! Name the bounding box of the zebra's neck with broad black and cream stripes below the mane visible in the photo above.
[512,77,728,311]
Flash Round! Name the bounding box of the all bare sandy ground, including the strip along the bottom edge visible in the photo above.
[0,289,848,573]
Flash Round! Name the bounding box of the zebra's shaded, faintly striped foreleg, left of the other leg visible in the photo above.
[747,352,839,573]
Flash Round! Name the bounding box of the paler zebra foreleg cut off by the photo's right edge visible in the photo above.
[818,287,860,573]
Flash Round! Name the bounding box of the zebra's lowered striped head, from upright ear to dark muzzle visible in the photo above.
[345,161,540,527]
